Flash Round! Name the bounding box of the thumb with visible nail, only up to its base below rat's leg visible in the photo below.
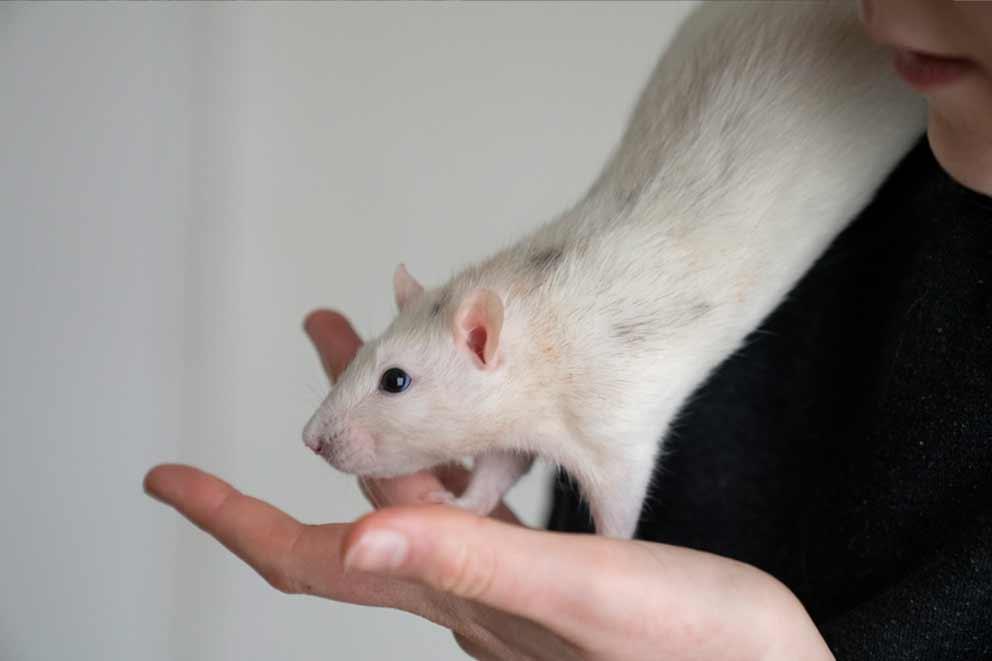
[341,505,615,634]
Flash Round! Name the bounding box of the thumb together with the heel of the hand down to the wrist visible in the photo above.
[340,505,832,659]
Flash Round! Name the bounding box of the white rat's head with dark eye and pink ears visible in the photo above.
[303,265,507,476]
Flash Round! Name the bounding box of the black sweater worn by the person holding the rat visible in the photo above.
[550,140,992,661]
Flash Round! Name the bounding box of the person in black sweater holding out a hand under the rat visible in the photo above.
[145,0,992,660]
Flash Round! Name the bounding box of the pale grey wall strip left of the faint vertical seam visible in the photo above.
[0,4,191,660]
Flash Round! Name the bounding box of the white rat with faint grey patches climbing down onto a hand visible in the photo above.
[303,2,925,537]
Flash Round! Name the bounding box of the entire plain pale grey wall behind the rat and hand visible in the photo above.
[0,3,690,661]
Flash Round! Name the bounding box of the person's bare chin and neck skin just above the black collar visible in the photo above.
[927,113,992,196]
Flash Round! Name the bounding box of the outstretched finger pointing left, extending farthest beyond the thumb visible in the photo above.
[144,465,424,608]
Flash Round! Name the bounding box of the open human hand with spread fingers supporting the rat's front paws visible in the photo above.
[145,312,833,661]
